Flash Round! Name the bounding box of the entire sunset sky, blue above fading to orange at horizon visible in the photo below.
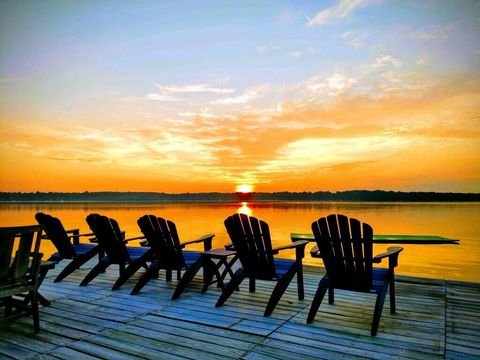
[0,0,480,192]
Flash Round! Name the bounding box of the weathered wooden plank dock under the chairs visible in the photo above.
[0,263,480,360]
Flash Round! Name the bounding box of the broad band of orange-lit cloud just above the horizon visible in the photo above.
[0,67,480,192]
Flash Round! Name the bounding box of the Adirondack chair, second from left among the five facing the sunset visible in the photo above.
[80,214,153,290]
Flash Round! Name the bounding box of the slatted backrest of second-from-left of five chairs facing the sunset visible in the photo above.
[87,214,130,264]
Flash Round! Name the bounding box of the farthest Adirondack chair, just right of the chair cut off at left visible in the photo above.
[35,212,103,282]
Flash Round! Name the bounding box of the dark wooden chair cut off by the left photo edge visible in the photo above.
[0,225,42,332]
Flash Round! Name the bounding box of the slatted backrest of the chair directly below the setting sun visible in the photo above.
[225,214,277,280]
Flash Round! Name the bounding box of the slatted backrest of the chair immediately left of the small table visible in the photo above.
[137,215,185,270]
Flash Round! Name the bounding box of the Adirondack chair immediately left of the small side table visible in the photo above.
[131,215,215,299]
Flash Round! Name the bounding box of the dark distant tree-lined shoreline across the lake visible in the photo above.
[0,190,480,204]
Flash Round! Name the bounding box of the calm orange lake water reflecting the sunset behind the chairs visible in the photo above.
[0,202,480,282]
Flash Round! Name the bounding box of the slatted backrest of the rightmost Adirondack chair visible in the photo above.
[312,214,373,291]
